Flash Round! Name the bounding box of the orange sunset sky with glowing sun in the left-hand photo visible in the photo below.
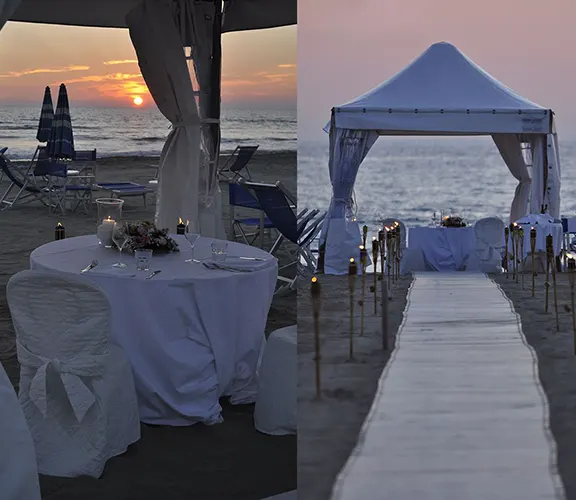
[0,23,296,106]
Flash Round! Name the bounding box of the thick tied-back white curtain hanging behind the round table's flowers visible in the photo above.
[126,0,200,232]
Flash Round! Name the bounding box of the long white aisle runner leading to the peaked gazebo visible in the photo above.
[333,273,564,500]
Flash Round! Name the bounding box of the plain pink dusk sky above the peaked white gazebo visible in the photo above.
[298,0,576,139]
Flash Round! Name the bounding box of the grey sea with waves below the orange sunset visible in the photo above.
[0,105,296,159]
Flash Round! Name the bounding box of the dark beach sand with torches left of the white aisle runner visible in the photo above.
[298,275,412,500]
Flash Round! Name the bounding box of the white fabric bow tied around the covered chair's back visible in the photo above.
[16,341,108,422]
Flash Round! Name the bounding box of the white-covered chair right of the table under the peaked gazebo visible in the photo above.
[466,217,504,273]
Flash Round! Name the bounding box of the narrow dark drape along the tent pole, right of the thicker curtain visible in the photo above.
[174,0,225,238]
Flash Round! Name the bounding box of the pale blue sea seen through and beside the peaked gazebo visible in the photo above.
[298,135,576,226]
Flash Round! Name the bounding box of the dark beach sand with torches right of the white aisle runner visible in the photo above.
[491,273,576,500]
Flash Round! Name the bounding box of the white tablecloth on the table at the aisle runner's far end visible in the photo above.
[408,227,475,271]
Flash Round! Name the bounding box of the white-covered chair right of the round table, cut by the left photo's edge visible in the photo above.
[254,325,298,436]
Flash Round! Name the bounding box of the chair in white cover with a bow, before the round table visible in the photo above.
[7,271,140,477]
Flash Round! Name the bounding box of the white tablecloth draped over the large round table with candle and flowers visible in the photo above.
[30,236,278,425]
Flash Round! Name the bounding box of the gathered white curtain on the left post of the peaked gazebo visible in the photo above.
[320,122,378,274]
